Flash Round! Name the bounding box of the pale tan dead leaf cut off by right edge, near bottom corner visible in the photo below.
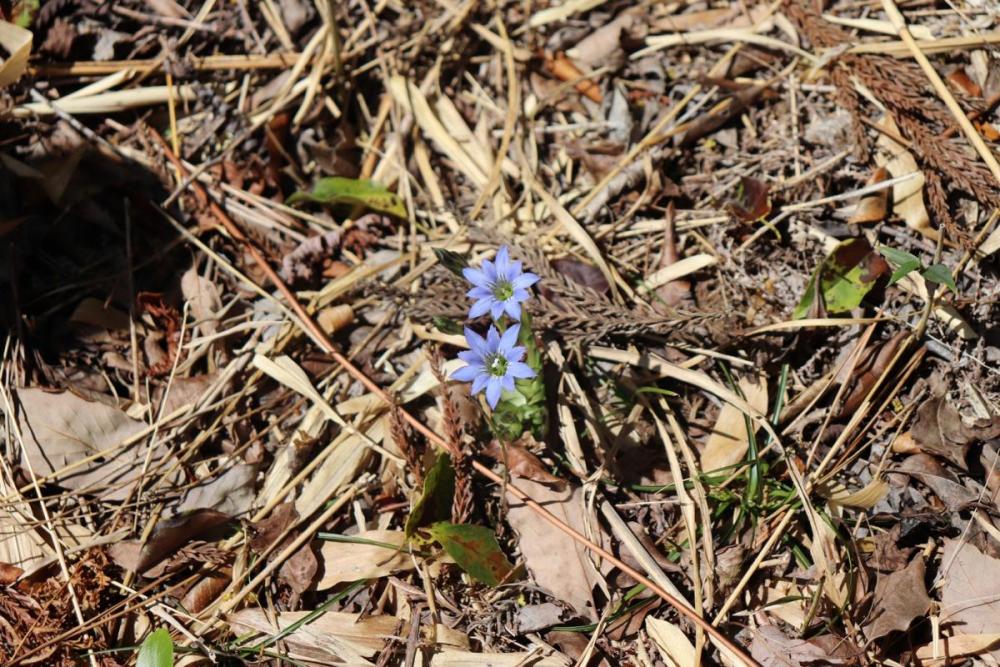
[939,539,1000,659]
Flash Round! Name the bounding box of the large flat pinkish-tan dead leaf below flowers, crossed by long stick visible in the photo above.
[507,479,600,620]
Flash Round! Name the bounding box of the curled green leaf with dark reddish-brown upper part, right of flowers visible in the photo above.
[793,237,889,320]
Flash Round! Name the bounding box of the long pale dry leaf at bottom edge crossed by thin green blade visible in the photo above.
[226,607,399,665]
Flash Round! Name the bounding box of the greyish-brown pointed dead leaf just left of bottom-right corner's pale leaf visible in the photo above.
[863,556,931,640]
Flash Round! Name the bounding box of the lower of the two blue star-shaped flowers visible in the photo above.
[451,324,535,408]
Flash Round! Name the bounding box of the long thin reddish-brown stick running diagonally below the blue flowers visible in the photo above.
[150,128,760,667]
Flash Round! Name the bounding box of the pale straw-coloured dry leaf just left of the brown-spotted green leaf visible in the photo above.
[316,530,416,591]
